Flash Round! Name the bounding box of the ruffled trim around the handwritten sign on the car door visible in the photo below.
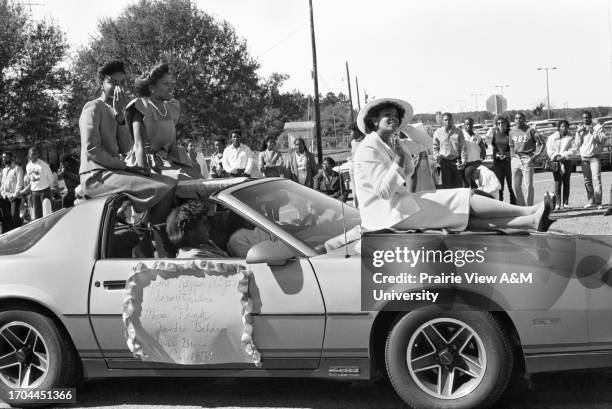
[122,260,261,367]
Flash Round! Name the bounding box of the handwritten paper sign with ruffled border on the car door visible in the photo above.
[123,260,260,366]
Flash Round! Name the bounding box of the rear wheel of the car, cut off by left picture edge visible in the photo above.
[0,310,82,407]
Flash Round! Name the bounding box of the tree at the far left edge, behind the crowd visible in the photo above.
[0,0,70,144]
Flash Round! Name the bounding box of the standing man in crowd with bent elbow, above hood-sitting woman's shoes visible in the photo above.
[510,112,546,206]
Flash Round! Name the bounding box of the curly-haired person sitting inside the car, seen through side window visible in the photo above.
[166,200,229,258]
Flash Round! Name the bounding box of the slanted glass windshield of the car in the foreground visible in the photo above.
[233,180,361,253]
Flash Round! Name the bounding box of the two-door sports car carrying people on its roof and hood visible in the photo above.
[0,178,612,409]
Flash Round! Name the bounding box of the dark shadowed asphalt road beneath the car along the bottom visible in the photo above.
[26,370,612,409]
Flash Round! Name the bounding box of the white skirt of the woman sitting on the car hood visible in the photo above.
[392,189,472,231]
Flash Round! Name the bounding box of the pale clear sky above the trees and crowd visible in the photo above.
[29,0,612,113]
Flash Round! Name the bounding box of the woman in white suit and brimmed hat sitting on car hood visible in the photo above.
[355,98,555,231]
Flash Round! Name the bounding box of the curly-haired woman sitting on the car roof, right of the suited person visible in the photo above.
[125,64,203,180]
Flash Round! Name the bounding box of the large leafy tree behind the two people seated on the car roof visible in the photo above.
[71,0,294,147]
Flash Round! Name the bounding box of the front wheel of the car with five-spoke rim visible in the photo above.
[385,307,513,409]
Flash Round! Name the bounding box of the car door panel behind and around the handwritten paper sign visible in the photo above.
[89,199,325,369]
